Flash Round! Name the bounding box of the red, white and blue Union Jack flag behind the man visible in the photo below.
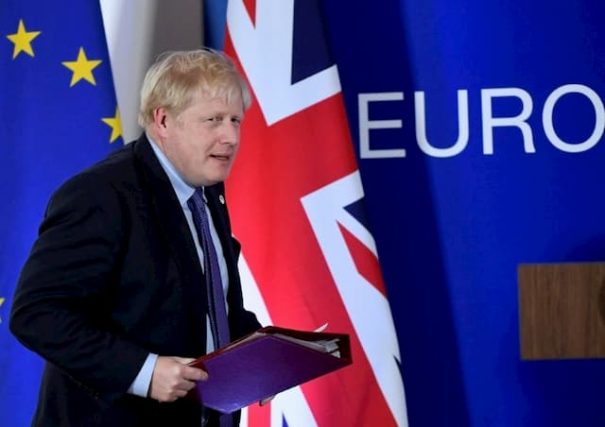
[225,0,407,427]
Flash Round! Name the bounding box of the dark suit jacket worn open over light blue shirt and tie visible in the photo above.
[10,136,260,427]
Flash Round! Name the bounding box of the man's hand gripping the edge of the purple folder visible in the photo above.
[149,356,208,402]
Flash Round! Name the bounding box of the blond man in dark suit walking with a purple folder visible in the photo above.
[10,50,260,427]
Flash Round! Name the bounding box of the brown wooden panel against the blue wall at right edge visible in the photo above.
[519,263,605,360]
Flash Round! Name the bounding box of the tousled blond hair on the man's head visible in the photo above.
[139,48,251,128]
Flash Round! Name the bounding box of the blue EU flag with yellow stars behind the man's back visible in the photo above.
[0,0,121,427]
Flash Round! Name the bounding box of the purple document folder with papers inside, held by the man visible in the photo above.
[189,326,351,413]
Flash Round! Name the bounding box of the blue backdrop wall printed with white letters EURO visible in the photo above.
[207,0,605,427]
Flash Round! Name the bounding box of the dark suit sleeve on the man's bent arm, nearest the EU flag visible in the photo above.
[10,172,148,400]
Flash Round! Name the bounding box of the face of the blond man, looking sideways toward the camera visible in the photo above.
[160,94,244,187]
